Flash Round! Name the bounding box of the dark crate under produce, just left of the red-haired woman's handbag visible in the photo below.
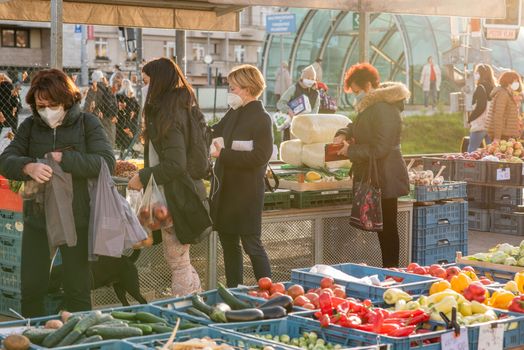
[291,190,353,209]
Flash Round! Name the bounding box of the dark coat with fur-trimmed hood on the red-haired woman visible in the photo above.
[337,83,409,198]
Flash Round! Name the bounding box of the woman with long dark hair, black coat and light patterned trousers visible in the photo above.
[129,58,210,296]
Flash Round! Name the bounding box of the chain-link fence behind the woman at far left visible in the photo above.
[0,66,143,159]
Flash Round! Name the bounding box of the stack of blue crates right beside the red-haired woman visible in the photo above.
[411,181,468,265]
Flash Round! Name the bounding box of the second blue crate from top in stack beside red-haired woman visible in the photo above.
[413,202,468,229]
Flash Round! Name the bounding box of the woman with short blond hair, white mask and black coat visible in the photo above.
[211,65,273,287]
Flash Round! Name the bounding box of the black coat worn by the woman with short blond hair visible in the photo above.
[211,101,273,235]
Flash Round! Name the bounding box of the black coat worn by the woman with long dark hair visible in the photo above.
[139,96,212,244]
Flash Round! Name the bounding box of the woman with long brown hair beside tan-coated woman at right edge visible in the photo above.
[468,63,495,152]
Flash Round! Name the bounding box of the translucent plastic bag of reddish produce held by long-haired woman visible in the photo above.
[137,175,173,232]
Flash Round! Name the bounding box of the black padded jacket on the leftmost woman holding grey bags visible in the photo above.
[0,104,116,229]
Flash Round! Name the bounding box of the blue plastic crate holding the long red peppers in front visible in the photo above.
[288,311,450,350]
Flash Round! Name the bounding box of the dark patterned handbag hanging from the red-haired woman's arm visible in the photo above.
[350,158,384,232]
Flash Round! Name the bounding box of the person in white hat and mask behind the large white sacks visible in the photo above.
[277,66,320,141]
